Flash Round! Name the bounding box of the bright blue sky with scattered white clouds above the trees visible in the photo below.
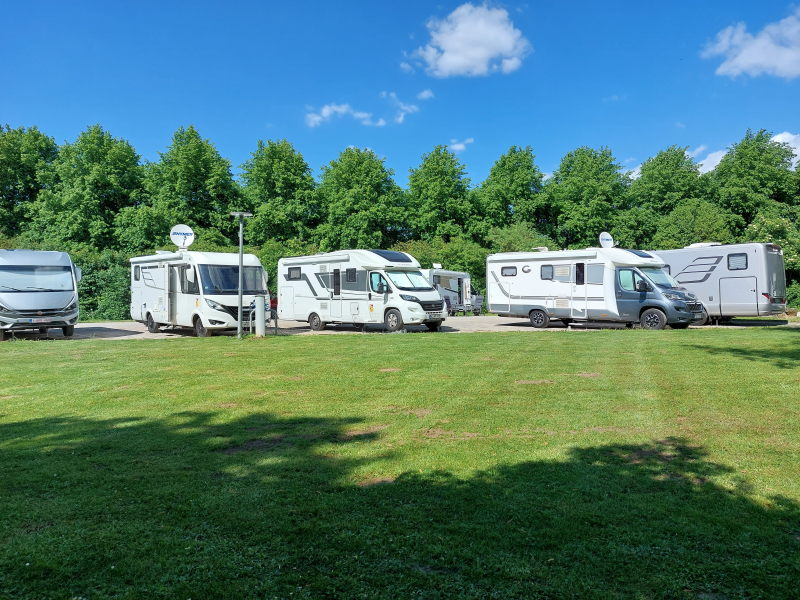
[0,0,800,185]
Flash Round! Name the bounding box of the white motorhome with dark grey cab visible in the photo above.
[486,247,702,329]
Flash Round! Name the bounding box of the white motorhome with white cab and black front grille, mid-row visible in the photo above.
[278,250,447,331]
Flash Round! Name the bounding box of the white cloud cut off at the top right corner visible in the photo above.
[700,8,800,79]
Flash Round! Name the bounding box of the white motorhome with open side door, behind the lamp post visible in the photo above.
[131,250,268,336]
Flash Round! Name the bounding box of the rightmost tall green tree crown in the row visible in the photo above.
[714,129,798,225]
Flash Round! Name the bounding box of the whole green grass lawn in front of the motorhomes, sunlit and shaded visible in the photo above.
[0,328,800,600]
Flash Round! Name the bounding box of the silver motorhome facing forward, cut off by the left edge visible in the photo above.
[0,250,81,339]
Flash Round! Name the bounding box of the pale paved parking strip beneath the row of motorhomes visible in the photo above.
[3,315,800,340]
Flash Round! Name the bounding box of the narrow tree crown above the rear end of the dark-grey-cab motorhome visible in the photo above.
[476,146,552,234]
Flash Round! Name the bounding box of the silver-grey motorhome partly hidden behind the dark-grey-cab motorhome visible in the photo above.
[651,242,786,321]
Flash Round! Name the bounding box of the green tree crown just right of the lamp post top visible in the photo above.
[242,140,320,244]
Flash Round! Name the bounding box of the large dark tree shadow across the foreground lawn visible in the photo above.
[0,413,800,599]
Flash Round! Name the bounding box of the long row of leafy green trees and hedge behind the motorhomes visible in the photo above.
[0,125,800,318]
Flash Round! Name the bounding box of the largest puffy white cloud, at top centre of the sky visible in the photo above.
[412,3,531,77]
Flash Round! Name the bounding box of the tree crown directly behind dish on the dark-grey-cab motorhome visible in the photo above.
[544,147,628,248]
